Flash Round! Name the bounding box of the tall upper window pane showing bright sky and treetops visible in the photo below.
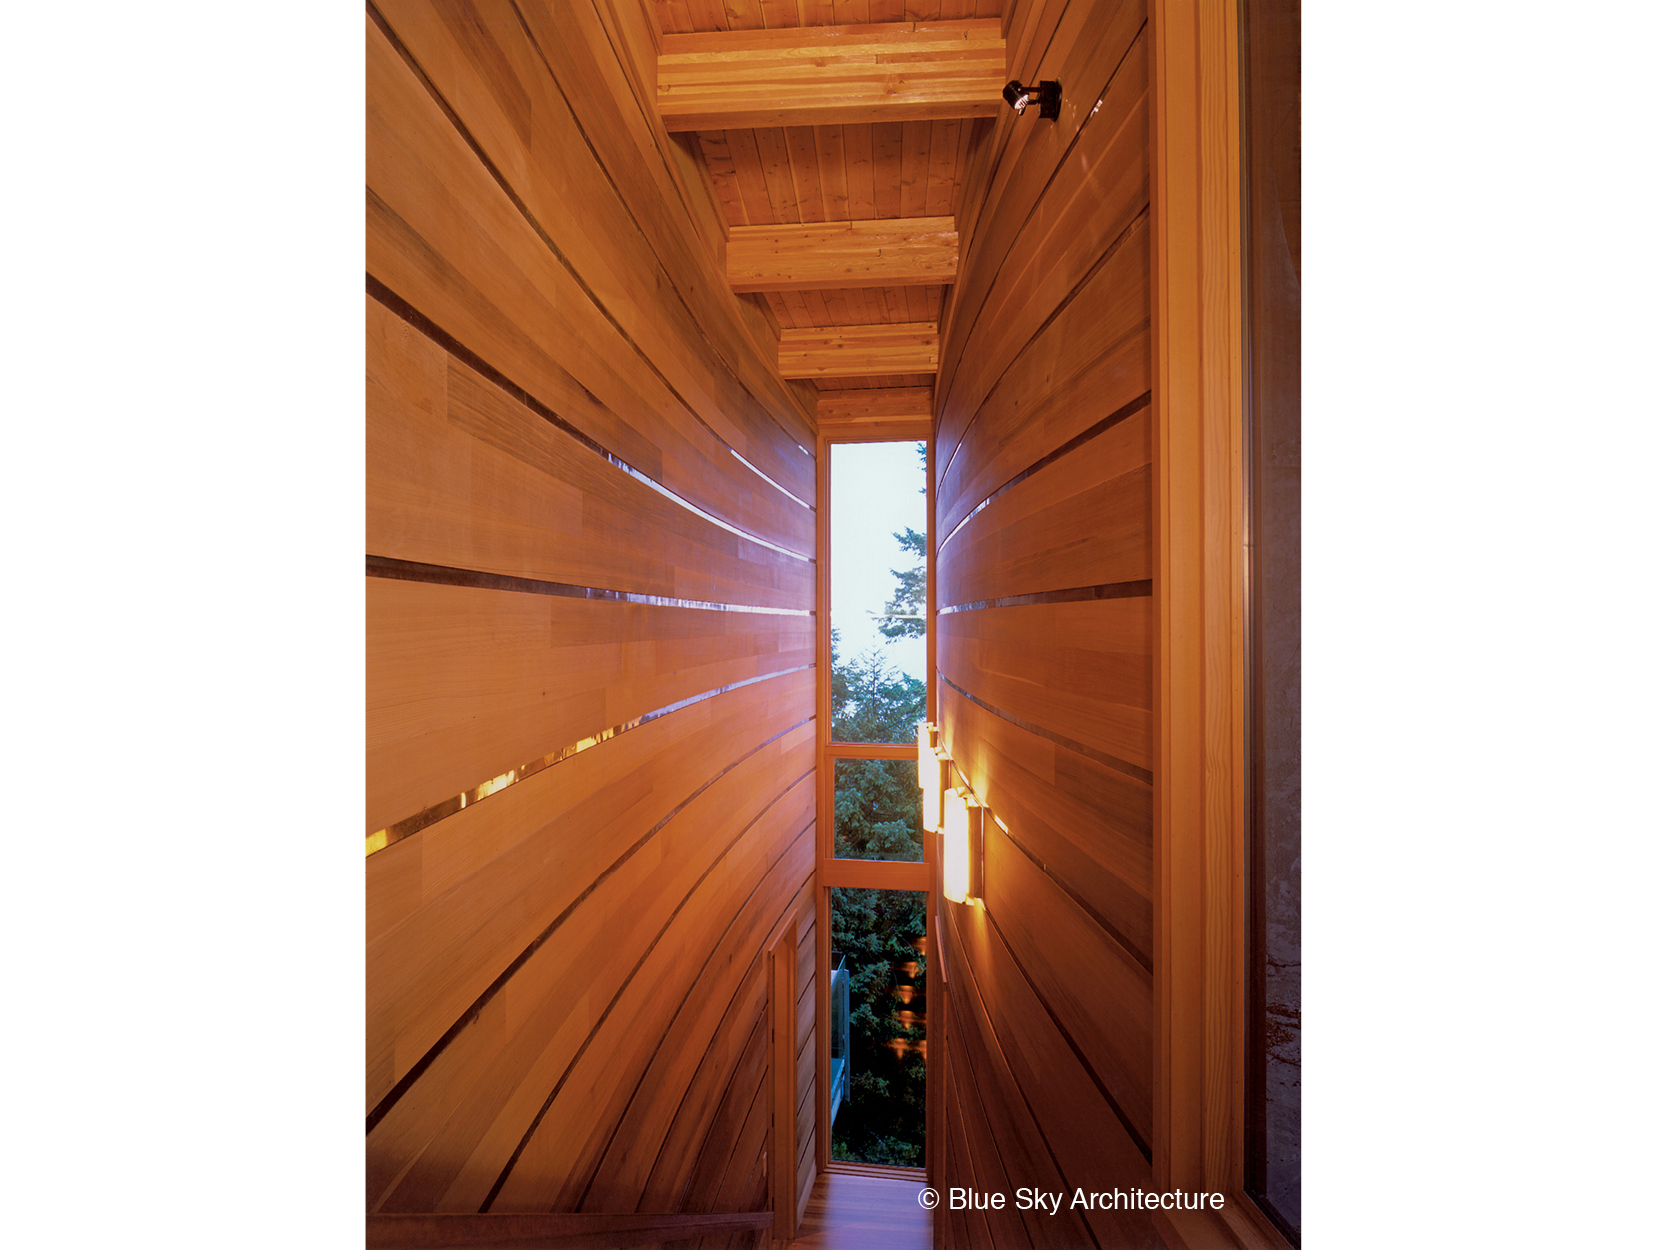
[828,443,927,742]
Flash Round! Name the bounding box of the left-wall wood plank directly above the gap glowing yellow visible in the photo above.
[365,577,815,833]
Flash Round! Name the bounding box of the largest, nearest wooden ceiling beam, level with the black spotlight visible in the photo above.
[657,17,1007,130]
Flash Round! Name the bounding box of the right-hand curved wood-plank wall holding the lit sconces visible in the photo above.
[935,0,1160,1250]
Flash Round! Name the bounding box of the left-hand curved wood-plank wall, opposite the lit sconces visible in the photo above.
[365,0,817,1242]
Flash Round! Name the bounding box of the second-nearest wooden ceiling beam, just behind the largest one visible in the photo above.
[728,217,960,292]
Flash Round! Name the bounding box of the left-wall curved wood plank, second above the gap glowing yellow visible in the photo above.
[365,298,815,610]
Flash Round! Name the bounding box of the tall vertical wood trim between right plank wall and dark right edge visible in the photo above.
[1152,0,1245,1192]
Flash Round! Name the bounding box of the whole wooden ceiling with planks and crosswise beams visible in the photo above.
[652,0,1005,412]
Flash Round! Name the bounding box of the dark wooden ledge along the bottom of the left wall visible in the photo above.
[365,1212,770,1250]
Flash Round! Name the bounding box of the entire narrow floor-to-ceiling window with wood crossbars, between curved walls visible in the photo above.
[818,438,935,1177]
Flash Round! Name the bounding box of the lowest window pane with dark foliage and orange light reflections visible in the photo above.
[828,887,927,1167]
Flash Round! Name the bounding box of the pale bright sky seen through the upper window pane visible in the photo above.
[828,443,927,682]
